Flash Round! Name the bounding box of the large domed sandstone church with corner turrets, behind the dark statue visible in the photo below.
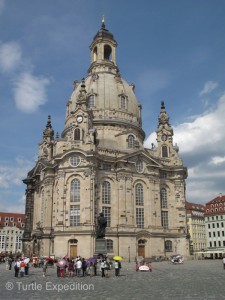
[23,21,189,261]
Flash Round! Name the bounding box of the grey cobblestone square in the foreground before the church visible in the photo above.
[0,260,225,300]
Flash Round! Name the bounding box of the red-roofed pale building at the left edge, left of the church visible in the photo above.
[0,212,25,254]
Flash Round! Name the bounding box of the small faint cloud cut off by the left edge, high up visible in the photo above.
[0,40,22,72]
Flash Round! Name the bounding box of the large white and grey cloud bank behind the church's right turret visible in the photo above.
[145,94,225,203]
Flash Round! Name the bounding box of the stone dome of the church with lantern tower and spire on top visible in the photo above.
[66,19,144,144]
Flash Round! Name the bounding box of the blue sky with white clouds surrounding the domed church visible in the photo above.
[0,0,225,213]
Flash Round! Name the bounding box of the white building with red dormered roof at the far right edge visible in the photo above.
[205,194,225,254]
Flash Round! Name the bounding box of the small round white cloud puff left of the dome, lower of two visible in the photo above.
[14,72,50,113]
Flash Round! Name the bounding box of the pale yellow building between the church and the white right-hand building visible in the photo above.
[186,202,206,254]
